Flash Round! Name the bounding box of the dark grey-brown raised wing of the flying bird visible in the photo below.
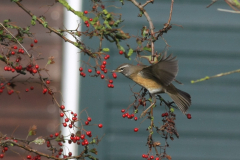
[141,55,178,86]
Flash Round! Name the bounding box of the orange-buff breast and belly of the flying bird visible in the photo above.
[129,73,165,94]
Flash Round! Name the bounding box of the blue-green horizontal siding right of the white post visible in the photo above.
[80,0,240,160]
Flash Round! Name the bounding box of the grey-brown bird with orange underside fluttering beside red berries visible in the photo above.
[112,54,191,115]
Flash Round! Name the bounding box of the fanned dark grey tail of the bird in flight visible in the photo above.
[167,88,191,114]
